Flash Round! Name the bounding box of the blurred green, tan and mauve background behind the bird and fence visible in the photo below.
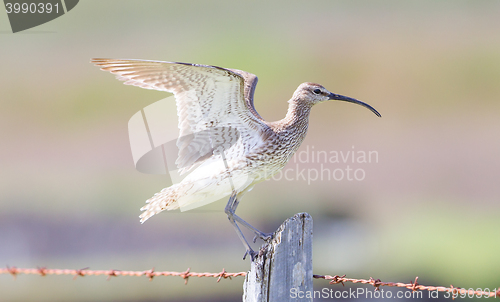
[0,0,500,301]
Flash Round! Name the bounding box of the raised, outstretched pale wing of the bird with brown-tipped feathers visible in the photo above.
[92,59,268,173]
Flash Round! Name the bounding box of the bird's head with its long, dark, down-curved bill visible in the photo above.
[292,83,381,117]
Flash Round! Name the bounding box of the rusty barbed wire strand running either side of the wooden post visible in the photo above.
[0,266,500,298]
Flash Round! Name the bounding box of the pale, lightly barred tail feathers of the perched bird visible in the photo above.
[139,184,188,223]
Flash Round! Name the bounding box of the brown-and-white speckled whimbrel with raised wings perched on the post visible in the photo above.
[92,59,380,259]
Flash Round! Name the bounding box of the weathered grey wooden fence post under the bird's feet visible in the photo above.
[243,213,313,302]
